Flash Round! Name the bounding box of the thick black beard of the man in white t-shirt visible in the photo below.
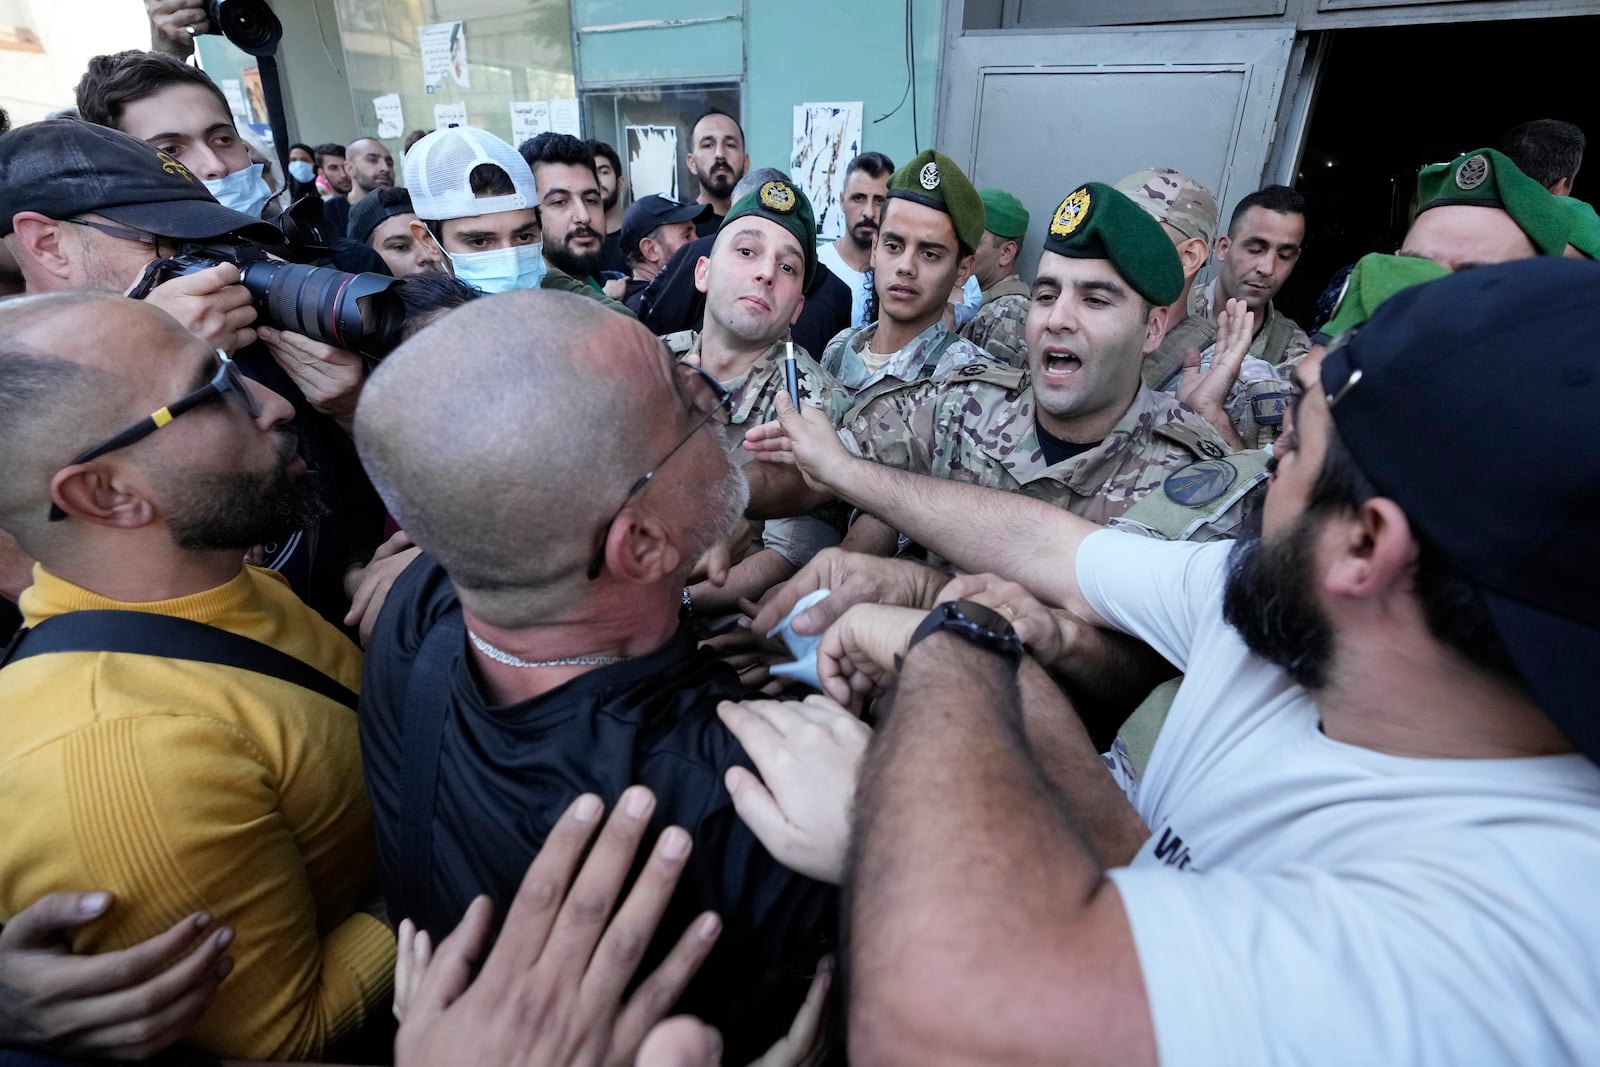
[1222,512,1333,691]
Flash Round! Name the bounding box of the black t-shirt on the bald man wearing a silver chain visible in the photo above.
[360,555,838,1062]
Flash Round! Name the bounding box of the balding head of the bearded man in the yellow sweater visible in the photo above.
[0,291,308,565]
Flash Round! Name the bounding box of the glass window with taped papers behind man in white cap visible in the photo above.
[334,0,578,155]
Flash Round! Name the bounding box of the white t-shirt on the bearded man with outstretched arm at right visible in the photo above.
[1077,531,1600,1067]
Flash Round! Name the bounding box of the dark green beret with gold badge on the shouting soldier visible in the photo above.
[1045,181,1184,306]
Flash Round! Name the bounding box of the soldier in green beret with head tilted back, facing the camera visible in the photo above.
[666,173,851,614]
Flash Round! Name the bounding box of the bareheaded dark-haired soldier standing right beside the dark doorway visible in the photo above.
[1189,186,1310,366]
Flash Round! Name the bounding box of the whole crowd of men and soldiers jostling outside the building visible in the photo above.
[0,12,1600,1067]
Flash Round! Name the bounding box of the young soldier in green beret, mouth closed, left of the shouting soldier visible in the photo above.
[822,149,995,400]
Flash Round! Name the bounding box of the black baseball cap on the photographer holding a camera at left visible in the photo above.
[0,118,283,243]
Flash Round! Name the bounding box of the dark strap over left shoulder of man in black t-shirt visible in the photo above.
[397,608,467,933]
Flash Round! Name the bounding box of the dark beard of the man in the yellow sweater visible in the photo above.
[168,432,330,552]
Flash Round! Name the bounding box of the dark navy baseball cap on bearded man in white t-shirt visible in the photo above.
[1322,256,1600,761]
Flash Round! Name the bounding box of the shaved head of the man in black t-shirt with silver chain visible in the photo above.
[355,290,726,625]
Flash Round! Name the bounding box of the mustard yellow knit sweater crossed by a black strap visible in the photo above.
[0,568,395,1059]
